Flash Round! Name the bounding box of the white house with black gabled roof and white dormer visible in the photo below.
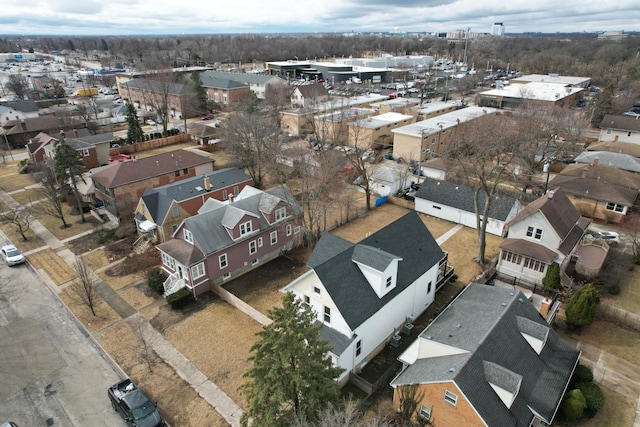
[283,212,453,384]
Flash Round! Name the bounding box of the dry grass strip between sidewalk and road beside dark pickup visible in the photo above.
[99,322,229,427]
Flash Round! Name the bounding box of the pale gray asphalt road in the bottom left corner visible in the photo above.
[0,242,124,427]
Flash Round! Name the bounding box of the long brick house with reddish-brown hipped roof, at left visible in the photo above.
[89,150,213,217]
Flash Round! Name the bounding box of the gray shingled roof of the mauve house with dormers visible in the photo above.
[165,186,300,256]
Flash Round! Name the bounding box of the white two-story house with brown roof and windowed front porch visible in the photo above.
[496,190,591,285]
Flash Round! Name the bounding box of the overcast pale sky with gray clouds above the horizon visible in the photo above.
[0,0,640,35]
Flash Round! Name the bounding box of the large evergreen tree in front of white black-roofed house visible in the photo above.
[241,293,342,427]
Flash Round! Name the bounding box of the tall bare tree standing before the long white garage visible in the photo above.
[443,114,519,268]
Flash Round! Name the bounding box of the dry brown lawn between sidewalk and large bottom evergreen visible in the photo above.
[161,299,262,407]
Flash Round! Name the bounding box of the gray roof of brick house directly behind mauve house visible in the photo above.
[142,168,251,224]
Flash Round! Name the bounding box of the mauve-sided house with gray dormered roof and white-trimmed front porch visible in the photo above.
[156,185,302,295]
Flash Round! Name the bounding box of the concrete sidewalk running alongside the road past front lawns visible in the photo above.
[0,191,243,427]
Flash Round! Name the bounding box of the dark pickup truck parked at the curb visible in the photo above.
[107,378,165,427]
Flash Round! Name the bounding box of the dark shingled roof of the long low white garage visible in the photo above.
[416,178,518,221]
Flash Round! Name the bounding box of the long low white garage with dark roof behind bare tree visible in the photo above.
[415,179,522,237]
